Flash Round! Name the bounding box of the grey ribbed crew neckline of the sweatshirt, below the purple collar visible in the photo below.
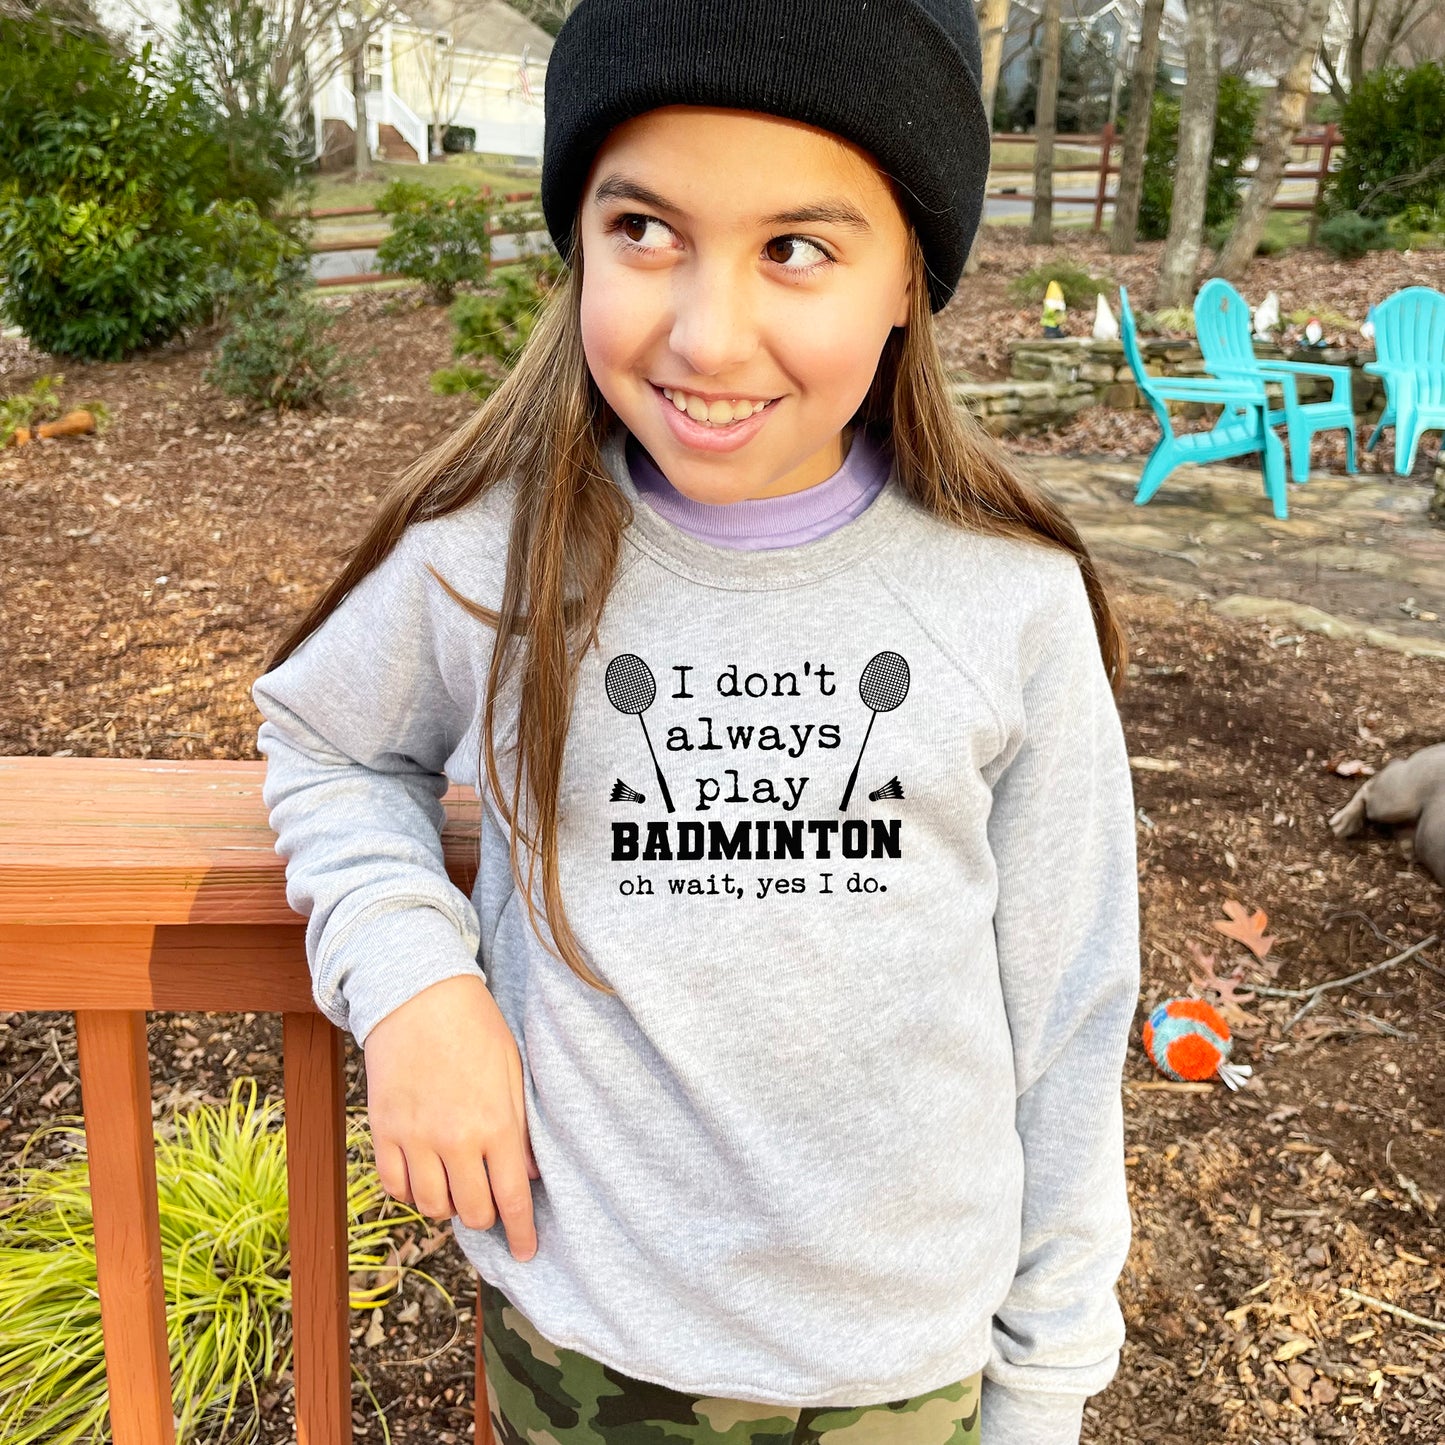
[601,422,909,591]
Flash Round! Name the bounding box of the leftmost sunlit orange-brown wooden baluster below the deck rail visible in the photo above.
[75,1011,176,1445]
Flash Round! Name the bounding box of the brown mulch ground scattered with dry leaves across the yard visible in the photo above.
[0,242,1445,1445]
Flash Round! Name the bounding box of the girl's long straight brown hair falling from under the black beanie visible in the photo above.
[266,227,1127,993]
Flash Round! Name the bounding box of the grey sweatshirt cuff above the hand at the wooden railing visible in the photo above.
[315,903,487,1045]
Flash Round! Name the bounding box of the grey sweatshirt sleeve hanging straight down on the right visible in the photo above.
[981,564,1139,1445]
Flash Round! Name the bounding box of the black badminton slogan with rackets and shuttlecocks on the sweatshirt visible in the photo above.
[604,650,910,899]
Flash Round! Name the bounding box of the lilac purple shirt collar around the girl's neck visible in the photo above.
[627,426,893,552]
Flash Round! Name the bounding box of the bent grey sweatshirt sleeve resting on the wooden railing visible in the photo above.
[251,526,490,1045]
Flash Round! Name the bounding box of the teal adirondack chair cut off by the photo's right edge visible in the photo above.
[1366,286,1445,477]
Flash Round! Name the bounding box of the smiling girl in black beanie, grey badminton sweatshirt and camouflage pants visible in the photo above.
[253,0,1139,1445]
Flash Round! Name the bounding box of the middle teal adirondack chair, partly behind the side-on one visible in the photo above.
[1194,277,1360,481]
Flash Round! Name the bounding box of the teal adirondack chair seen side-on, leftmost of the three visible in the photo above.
[1118,286,1289,517]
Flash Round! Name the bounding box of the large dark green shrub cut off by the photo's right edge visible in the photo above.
[1325,61,1445,215]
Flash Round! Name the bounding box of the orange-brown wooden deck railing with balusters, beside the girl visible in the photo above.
[0,757,491,1445]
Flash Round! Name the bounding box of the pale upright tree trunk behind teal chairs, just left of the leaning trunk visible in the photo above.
[1155,0,1220,308]
